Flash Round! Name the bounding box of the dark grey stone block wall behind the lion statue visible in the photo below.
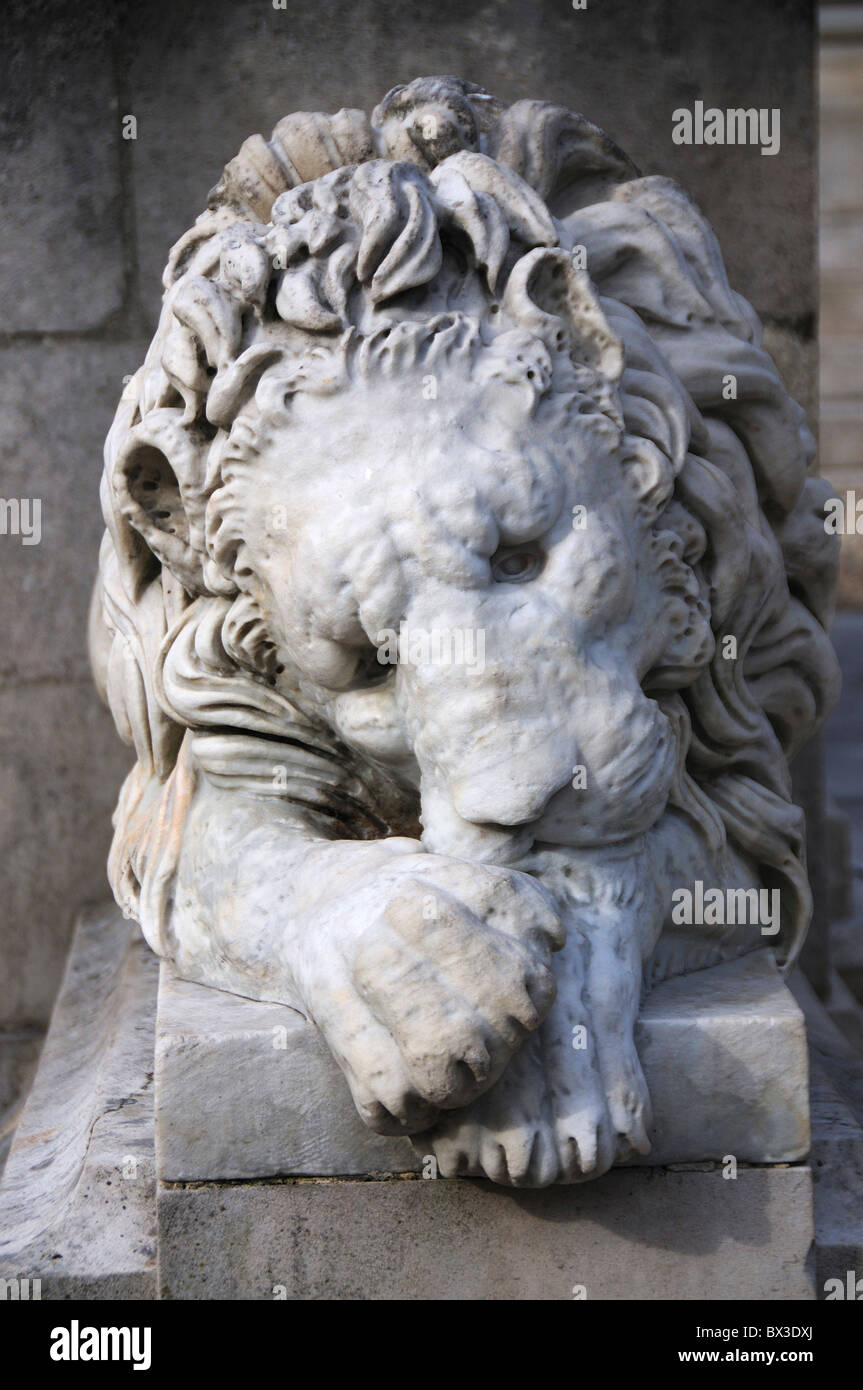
[0,0,833,1112]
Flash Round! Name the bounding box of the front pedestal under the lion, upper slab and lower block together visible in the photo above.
[156,952,812,1300]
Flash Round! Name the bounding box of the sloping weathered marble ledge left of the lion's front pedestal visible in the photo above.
[0,905,157,1298]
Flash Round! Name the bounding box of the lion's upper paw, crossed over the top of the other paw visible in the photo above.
[296,855,563,1134]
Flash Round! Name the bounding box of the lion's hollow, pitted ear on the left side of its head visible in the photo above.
[113,409,208,594]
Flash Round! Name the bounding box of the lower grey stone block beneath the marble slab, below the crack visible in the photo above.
[157,1166,814,1301]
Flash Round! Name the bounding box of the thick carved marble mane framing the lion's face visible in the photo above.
[92,78,837,974]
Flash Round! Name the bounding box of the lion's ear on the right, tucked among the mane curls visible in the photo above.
[503,247,624,381]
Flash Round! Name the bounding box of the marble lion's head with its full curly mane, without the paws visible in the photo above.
[93,78,837,972]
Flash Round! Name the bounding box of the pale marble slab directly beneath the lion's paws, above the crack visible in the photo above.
[156,951,809,1182]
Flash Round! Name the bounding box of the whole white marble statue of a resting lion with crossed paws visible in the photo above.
[90,76,838,1186]
